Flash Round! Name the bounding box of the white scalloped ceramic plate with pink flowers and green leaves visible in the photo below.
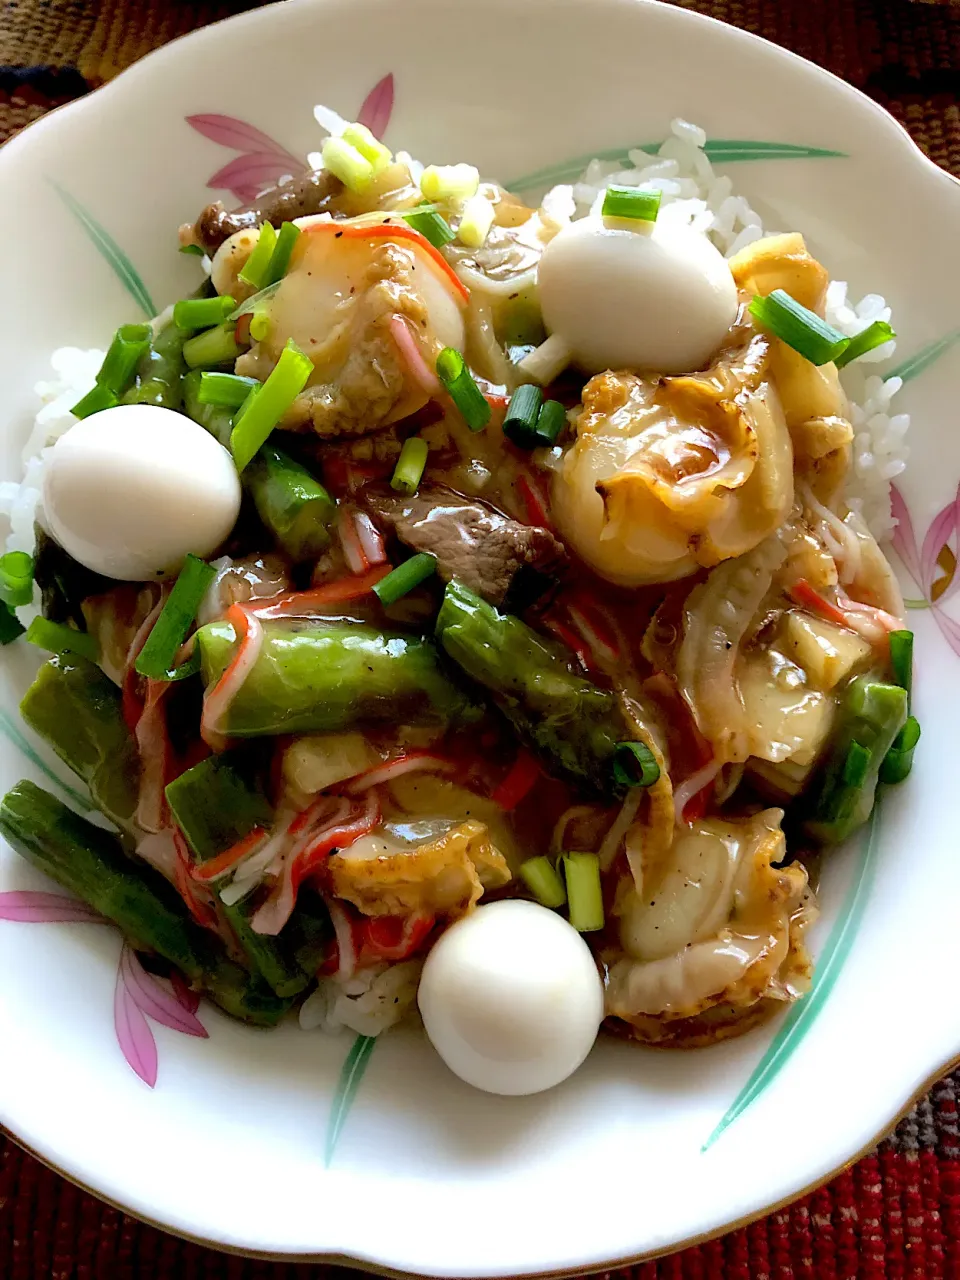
[0,0,960,1275]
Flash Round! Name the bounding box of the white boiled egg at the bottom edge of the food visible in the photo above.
[419,899,603,1094]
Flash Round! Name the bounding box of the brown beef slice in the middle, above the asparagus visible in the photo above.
[364,484,567,605]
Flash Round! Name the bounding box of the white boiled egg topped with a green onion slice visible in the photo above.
[538,216,737,374]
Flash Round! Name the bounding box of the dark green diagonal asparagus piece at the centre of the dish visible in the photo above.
[436,581,628,796]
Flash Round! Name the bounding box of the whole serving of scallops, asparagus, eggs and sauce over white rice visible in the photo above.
[0,117,919,1092]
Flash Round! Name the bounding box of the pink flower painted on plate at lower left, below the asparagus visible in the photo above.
[0,890,207,1089]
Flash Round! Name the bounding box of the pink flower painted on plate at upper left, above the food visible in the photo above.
[186,74,393,204]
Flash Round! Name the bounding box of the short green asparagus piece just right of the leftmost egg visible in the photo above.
[243,444,337,563]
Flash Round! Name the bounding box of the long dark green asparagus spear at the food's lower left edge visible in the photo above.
[0,781,292,1027]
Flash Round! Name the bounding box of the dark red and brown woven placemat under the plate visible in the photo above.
[0,0,960,1280]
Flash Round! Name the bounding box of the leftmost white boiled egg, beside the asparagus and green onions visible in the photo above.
[42,404,241,581]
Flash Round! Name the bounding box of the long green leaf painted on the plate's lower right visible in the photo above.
[700,803,879,1152]
